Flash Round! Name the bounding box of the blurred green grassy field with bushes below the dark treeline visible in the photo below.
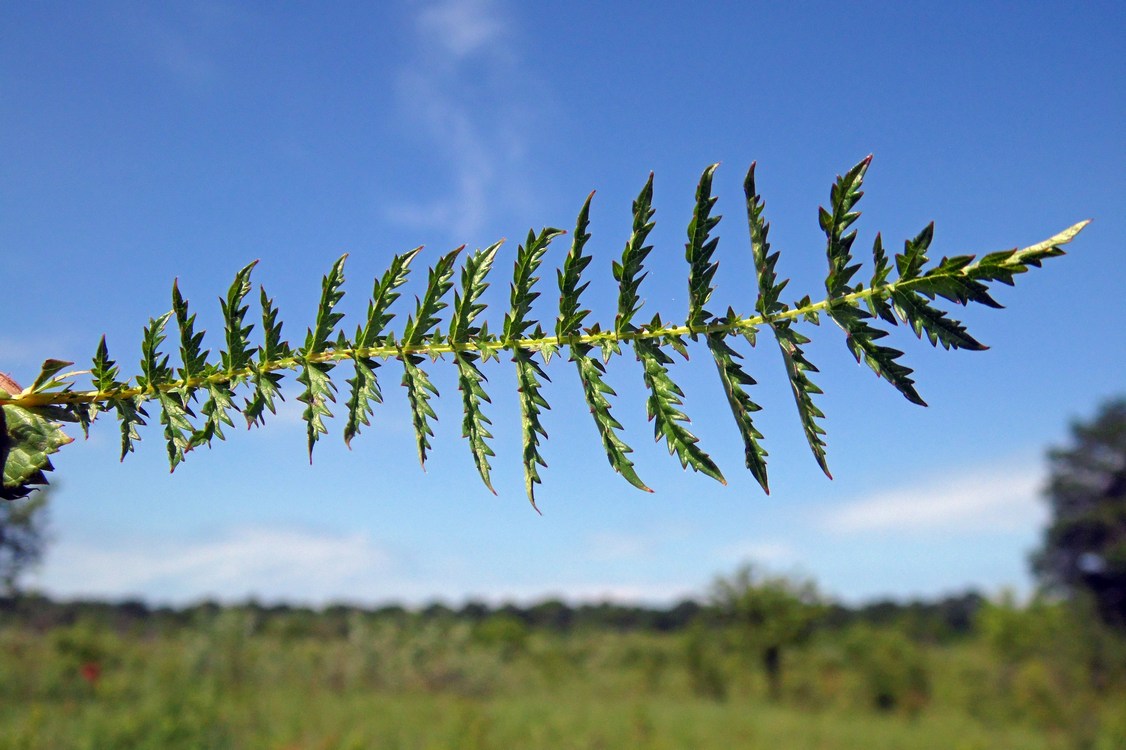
[0,605,1126,750]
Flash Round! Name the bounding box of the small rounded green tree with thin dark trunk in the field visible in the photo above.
[711,565,824,699]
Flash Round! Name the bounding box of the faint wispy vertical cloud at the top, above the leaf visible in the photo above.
[386,0,533,241]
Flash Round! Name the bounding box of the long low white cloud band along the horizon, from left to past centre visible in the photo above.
[29,526,698,605]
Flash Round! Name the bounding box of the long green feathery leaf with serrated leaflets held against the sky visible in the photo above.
[0,155,1088,507]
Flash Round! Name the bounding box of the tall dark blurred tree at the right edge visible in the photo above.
[1031,399,1126,628]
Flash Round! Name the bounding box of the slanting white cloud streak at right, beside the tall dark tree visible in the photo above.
[820,459,1047,534]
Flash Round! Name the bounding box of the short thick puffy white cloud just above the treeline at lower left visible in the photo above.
[38,527,390,601]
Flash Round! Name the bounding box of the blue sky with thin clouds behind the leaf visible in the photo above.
[0,0,1126,604]
